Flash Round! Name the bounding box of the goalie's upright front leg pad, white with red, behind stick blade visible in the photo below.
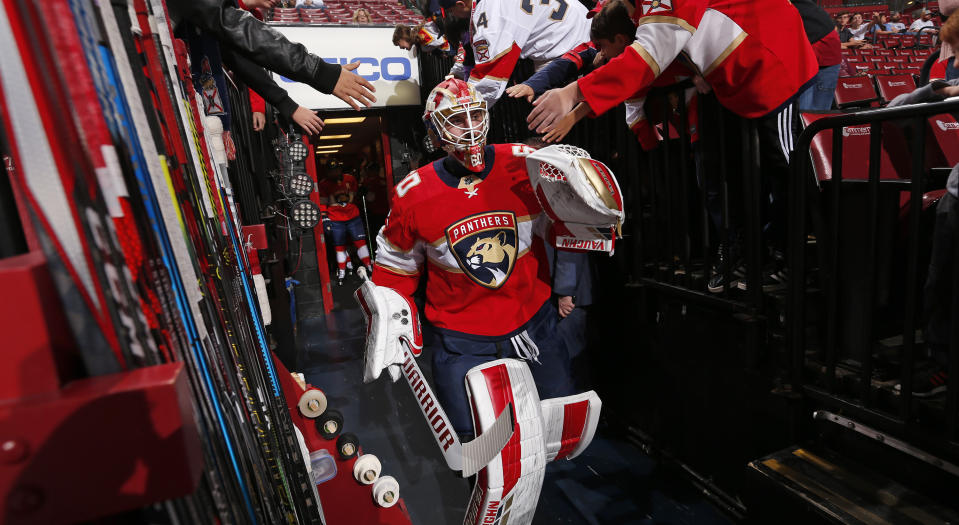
[464,359,546,525]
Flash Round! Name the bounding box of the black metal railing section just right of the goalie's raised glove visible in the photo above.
[631,81,763,311]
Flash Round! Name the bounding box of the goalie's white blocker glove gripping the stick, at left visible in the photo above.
[354,279,423,383]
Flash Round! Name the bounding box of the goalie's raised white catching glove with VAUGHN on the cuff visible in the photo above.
[526,144,626,254]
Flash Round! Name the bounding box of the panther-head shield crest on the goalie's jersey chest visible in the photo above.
[446,211,517,290]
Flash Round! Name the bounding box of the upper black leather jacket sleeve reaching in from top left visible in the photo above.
[167,0,340,94]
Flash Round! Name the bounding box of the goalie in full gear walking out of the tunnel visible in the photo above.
[356,79,623,524]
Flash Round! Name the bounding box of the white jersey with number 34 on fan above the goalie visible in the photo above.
[469,0,590,107]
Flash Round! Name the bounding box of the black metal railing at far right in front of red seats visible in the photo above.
[787,101,959,457]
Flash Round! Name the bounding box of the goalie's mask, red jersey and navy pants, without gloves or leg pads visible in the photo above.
[373,79,572,435]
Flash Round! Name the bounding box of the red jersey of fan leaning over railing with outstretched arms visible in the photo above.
[578,0,819,118]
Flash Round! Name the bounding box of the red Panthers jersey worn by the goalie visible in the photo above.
[373,144,550,337]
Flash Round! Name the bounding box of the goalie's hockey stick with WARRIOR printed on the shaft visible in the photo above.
[356,267,516,478]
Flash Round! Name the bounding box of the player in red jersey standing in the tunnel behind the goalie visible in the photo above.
[317,166,372,285]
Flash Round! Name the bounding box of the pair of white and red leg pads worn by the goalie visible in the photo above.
[463,359,601,525]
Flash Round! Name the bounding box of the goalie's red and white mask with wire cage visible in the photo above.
[423,78,489,172]
